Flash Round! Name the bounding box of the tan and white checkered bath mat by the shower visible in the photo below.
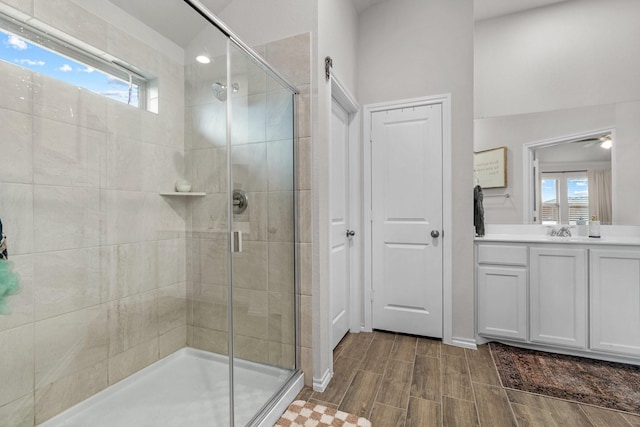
[274,400,371,427]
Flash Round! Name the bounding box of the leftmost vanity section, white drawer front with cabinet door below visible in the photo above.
[476,244,528,341]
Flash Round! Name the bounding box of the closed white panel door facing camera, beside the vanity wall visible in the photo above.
[371,104,443,338]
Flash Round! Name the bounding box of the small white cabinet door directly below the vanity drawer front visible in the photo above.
[477,265,527,341]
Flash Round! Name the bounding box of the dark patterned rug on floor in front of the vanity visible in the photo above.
[490,342,640,414]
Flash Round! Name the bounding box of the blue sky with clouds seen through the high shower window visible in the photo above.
[0,29,139,106]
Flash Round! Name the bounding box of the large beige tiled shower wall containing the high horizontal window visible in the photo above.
[0,0,187,426]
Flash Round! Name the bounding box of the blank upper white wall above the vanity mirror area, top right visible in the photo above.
[475,0,640,118]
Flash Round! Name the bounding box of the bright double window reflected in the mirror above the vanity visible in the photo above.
[540,172,589,224]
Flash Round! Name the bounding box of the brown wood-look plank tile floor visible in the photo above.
[297,331,640,427]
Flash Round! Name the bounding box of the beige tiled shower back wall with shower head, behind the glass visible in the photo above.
[185,34,311,379]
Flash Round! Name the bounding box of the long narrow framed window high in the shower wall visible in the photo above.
[0,14,147,108]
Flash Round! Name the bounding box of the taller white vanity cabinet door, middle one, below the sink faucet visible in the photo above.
[529,247,587,348]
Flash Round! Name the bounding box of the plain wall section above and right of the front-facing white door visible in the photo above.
[357,0,474,339]
